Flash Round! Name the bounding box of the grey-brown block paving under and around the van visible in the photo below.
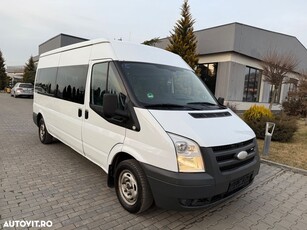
[0,93,307,230]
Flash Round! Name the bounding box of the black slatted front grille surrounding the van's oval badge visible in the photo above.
[212,139,256,172]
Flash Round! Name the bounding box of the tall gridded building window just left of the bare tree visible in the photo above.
[243,66,262,102]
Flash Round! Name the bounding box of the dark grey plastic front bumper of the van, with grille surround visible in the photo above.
[142,140,260,210]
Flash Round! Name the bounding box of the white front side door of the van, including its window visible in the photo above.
[82,61,126,171]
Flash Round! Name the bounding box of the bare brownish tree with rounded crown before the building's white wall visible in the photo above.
[260,50,299,109]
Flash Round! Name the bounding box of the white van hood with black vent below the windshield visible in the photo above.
[149,109,255,147]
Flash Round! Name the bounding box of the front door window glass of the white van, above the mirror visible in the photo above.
[90,62,126,110]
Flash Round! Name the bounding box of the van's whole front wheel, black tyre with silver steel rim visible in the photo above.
[115,159,153,213]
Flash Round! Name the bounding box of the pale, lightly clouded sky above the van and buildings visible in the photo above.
[0,0,307,66]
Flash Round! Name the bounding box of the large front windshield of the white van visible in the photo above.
[119,62,220,109]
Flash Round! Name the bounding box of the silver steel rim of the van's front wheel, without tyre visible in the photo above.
[118,170,138,205]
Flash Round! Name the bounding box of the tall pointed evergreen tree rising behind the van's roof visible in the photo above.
[166,0,198,70]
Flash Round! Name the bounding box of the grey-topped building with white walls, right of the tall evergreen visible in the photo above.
[156,23,307,110]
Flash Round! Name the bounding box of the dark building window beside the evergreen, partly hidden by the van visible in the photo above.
[198,63,218,94]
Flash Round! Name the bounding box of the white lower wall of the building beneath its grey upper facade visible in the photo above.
[199,52,297,110]
